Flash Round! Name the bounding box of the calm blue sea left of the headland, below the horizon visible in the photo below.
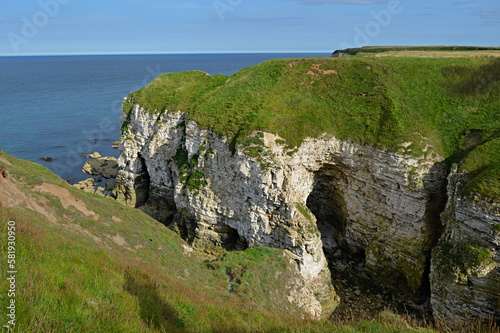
[0,53,329,184]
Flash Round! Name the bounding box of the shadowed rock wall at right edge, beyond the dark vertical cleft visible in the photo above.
[431,165,500,323]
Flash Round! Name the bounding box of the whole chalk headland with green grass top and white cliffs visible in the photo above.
[116,57,500,321]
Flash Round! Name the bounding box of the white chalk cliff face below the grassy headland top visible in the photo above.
[116,105,454,317]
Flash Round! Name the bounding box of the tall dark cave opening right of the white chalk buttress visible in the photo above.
[306,164,434,317]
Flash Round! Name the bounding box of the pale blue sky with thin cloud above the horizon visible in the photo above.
[0,0,500,56]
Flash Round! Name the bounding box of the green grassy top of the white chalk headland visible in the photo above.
[124,56,500,199]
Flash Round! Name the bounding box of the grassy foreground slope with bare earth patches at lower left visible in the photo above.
[0,151,446,333]
